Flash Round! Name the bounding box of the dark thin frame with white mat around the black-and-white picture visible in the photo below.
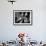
[13,10,33,26]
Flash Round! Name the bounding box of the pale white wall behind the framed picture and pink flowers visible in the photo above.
[0,0,46,41]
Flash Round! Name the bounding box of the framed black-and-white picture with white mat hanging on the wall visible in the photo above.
[13,10,32,25]
